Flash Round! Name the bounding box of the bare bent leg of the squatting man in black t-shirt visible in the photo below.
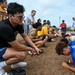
[3,48,26,65]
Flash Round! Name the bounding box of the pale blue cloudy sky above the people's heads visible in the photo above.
[7,0,75,27]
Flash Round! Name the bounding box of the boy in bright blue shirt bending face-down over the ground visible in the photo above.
[55,42,75,72]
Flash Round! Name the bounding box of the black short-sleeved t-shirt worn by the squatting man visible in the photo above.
[0,19,24,47]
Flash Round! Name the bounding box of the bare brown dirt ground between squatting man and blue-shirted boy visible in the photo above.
[25,38,75,75]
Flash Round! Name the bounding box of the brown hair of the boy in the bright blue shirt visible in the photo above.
[55,42,68,55]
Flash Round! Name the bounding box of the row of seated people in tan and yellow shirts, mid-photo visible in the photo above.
[25,19,61,54]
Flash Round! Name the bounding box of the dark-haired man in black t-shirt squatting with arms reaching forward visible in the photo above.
[0,3,40,75]
